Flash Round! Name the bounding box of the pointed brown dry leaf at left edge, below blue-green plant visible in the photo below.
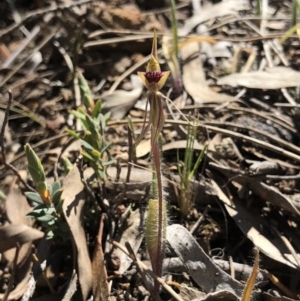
[0,224,44,252]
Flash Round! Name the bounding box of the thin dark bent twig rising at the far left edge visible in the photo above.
[0,90,35,192]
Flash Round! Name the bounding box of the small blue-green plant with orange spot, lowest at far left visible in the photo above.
[25,144,68,239]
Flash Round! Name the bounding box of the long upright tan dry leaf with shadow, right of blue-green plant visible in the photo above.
[61,166,92,301]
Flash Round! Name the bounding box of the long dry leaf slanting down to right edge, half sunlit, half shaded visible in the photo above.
[212,181,299,269]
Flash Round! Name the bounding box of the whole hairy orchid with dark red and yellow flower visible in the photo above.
[136,30,170,293]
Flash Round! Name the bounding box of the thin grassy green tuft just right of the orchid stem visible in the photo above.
[177,116,207,216]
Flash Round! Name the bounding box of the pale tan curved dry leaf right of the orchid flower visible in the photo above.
[181,43,234,103]
